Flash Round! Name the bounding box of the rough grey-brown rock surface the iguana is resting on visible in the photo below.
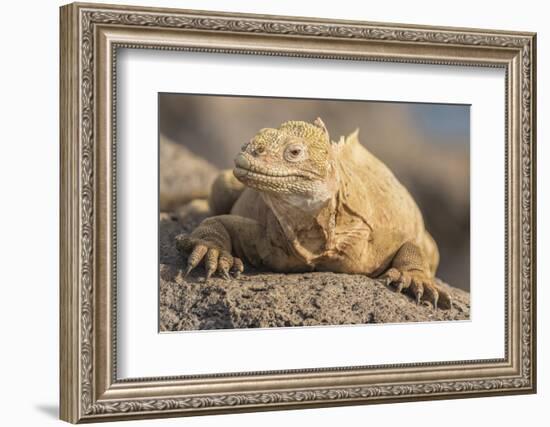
[160,210,470,331]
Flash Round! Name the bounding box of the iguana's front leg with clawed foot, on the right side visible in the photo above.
[381,242,452,309]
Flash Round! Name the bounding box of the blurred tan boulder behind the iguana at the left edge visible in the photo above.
[160,135,218,211]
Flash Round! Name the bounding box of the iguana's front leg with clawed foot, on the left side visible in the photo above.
[176,215,265,279]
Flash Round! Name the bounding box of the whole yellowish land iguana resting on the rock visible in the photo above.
[176,118,452,308]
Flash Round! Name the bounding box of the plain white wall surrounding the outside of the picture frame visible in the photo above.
[0,0,550,427]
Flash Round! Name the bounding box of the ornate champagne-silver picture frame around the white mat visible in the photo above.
[60,3,536,423]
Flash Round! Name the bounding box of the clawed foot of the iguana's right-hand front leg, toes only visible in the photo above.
[381,267,453,309]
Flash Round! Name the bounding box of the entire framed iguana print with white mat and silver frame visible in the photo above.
[60,4,536,423]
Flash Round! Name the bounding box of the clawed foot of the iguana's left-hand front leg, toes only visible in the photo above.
[176,235,244,280]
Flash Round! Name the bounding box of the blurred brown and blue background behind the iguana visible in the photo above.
[159,93,470,290]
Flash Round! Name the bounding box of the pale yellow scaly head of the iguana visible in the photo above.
[233,118,332,209]
